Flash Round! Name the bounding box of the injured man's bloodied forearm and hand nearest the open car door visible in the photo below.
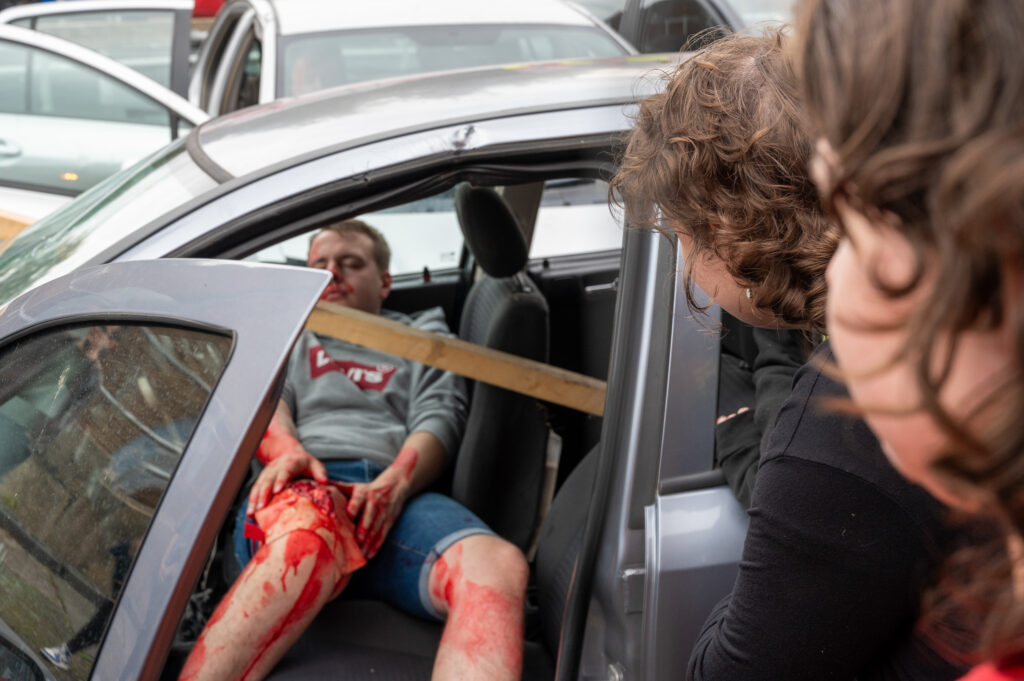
[246,399,328,516]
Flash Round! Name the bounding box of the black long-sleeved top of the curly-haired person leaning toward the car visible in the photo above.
[688,344,966,681]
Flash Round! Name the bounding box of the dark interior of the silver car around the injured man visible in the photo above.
[150,177,622,679]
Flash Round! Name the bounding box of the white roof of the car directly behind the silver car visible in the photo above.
[271,0,594,36]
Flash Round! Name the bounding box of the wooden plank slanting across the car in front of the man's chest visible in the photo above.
[306,301,607,416]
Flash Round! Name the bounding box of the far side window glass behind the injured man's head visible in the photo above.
[249,189,463,274]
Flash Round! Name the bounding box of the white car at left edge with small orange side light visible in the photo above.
[0,26,209,218]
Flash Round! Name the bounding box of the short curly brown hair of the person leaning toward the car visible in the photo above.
[611,31,838,331]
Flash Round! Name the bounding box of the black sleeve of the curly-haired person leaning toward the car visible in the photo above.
[687,450,923,681]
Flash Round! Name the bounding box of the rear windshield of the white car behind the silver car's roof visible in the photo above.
[279,26,627,96]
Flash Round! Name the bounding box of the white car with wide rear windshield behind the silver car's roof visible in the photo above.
[188,0,634,115]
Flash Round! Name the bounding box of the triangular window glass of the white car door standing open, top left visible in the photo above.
[36,9,174,87]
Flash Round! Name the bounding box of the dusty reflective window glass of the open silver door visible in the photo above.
[0,325,230,679]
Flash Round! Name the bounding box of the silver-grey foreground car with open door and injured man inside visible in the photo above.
[0,57,746,680]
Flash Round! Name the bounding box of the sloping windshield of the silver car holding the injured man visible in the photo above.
[0,139,217,305]
